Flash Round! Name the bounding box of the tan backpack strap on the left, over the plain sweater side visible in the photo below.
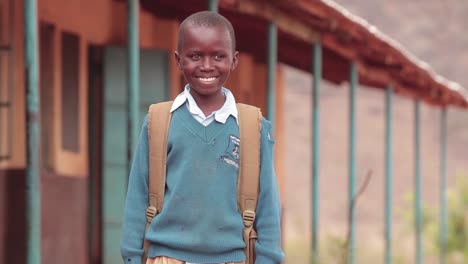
[144,102,172,259]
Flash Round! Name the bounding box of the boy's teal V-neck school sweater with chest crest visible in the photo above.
[121,106,283,264]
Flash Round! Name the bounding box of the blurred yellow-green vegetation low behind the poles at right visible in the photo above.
[285,173,468,264]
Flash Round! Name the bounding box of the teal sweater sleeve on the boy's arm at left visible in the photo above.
[120,117,148,264]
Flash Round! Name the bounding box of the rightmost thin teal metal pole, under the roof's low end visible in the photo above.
[439,108,447,264]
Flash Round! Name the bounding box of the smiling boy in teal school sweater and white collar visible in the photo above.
[121,11,283,264]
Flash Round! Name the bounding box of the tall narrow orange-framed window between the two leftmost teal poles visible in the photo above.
[51,29,88,177]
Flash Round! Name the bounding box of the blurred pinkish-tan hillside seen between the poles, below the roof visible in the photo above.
[283,68,468,264]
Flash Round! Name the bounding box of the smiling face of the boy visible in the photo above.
[175,25,238,99]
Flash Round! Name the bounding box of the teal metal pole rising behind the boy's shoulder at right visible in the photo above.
[267,22,278,129]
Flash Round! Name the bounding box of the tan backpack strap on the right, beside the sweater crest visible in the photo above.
[237,104,262,263]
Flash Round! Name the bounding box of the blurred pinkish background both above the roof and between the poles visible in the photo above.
[284,0,468,263]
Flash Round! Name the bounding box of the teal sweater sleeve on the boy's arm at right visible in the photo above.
[254,119,284,264]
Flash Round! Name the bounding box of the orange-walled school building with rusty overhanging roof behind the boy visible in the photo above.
[0,0,468,264]
